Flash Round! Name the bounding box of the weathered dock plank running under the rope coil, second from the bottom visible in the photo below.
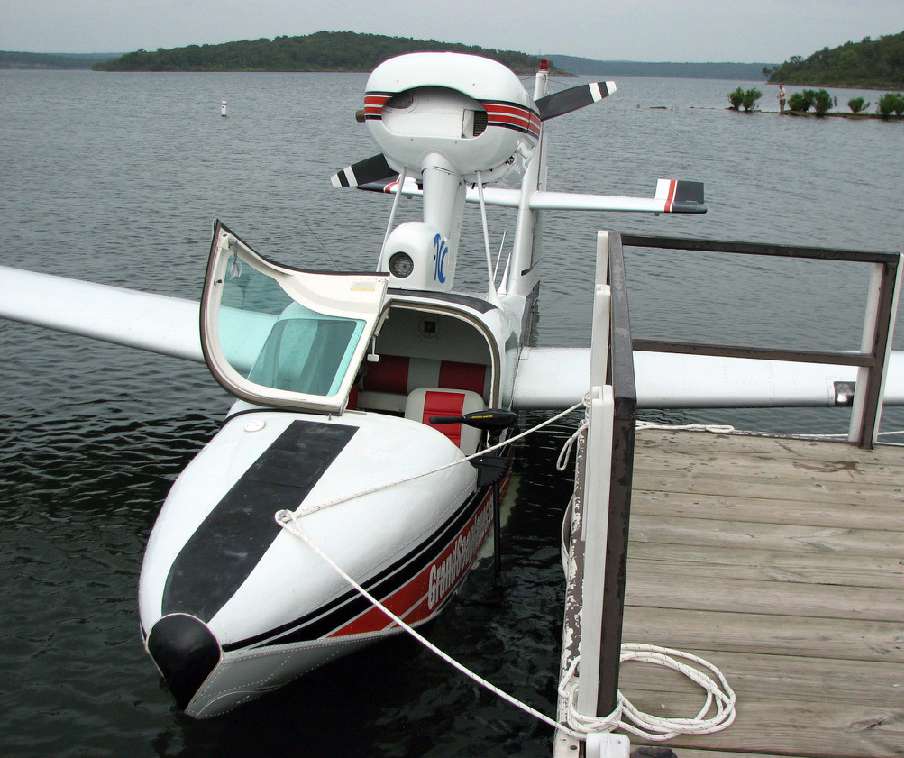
[619,650,904,714]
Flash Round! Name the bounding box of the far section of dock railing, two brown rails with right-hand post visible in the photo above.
[624,234,904,449]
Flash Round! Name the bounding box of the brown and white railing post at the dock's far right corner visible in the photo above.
[848,255,902,449]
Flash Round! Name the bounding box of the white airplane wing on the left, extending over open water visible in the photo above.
[0,266,204,363]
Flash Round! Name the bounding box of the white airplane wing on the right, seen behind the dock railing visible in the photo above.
[513,348,904,409]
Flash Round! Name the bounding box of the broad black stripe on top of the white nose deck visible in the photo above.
[161,421,358,621]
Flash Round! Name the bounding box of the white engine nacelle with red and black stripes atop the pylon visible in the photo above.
[364,53,540,182]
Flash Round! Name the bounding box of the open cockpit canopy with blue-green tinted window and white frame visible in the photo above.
[201,222,387,412]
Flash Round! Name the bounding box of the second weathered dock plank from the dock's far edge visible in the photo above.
[634,470,904,510]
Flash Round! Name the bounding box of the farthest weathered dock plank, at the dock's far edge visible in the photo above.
[635,429,904,466]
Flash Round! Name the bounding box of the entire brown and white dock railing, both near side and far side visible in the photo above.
[554,232,902,756]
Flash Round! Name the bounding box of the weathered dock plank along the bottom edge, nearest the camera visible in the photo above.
[620,690,904,758]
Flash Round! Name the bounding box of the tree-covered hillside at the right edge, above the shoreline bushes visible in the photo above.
[769,32,904,89]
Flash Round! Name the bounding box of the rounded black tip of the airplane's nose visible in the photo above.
[147,613,222,709]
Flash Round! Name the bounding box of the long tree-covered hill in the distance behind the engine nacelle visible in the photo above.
[95,32,556,73]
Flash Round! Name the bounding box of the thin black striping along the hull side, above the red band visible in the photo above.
[223,480,498,652]
